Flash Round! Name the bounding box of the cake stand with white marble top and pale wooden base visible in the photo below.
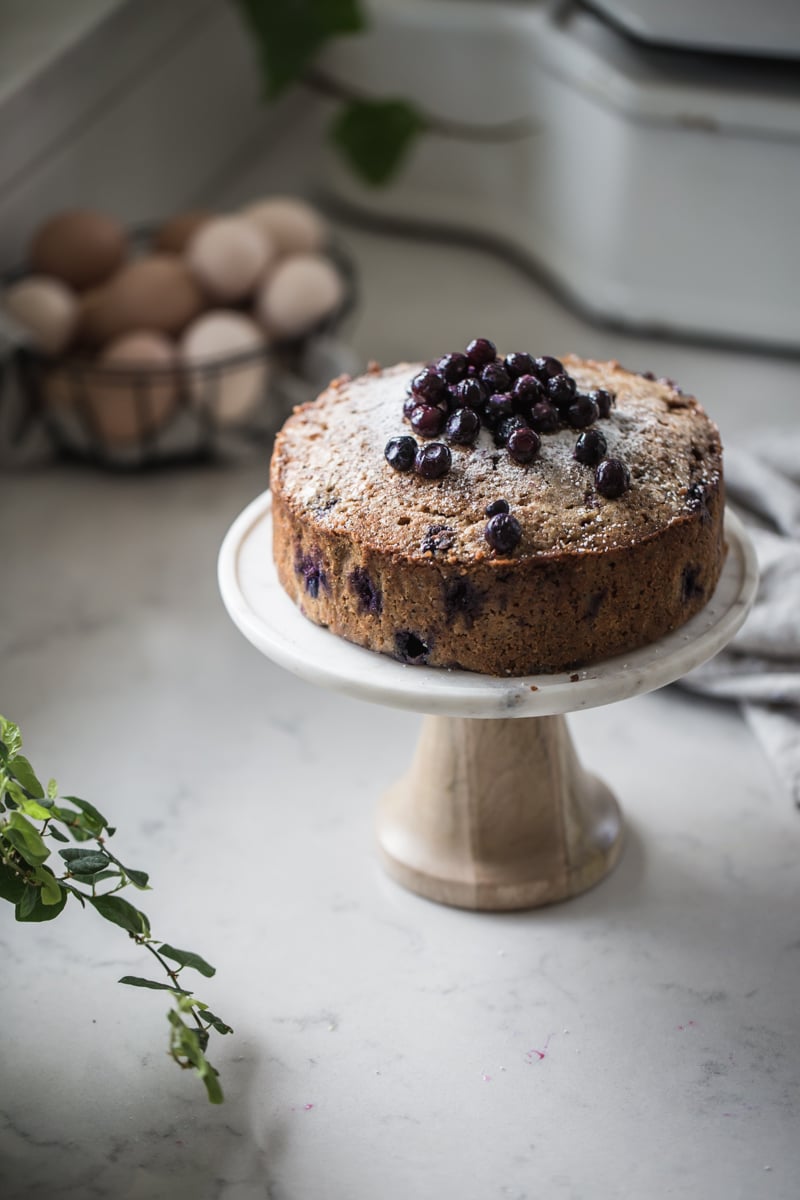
[218,492,758,910]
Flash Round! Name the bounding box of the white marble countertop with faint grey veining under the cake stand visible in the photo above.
[0,218,800,1200]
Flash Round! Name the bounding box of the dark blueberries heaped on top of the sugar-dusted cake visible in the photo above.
[384,337,631,553]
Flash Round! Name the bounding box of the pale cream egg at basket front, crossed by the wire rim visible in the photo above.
[180,310,269,425]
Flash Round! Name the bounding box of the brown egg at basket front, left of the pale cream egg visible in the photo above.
[78,330,179,446]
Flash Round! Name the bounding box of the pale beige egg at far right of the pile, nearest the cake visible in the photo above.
[255,254,344,337]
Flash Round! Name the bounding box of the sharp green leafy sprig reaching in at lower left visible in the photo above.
[0,716,233,1104]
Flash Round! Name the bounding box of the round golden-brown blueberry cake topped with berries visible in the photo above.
[271,338,724,674]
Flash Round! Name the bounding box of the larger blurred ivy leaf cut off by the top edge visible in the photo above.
[236,0,365,97]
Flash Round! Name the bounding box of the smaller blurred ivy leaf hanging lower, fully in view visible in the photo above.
[331,100,428,187]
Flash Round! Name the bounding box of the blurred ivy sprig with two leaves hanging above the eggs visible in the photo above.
[235,0,535,187]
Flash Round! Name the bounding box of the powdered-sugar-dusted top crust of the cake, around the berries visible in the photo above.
[282,359,718,563]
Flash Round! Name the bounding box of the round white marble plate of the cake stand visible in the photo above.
[218,491,758,718]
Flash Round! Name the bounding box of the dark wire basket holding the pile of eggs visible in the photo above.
[0,234,356,469]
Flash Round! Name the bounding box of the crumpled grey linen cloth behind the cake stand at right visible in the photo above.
[681,430,800,808]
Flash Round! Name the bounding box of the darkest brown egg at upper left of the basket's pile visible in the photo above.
[28,209,127,290]
